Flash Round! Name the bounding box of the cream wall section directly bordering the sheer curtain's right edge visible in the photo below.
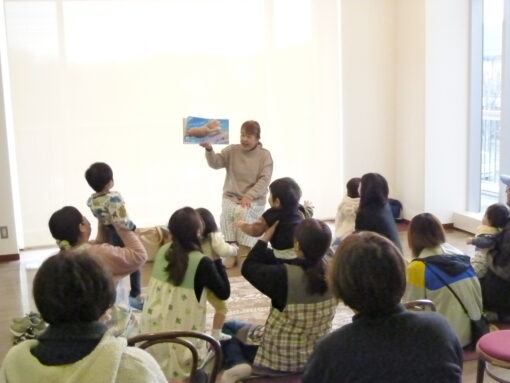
[341,0,399,189]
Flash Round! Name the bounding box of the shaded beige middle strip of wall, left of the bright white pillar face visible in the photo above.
[394,0,426,219]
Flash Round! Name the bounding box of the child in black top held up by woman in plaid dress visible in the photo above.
[236,177,304,259]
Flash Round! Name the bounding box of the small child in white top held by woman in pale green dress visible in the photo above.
[195,207,237,341]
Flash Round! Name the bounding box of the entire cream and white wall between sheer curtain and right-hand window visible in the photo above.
[342,0,469,223]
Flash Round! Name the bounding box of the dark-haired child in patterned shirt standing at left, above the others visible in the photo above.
[85,162,143,310]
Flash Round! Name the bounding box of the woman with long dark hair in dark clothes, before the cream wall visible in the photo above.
[355,173,402,250]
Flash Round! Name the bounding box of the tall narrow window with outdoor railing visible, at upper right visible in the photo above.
[469,0,504,211]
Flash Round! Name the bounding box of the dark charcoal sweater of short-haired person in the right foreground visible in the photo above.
[303,306,462,383]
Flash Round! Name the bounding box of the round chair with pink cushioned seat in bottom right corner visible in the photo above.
[476,330,510,383]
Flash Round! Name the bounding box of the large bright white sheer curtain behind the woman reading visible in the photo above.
[4,0,343,246]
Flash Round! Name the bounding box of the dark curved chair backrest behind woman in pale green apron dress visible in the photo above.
[128,331,223,383]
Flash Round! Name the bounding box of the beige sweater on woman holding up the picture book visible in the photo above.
[205,144,273,204]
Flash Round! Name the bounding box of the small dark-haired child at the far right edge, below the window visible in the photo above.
[466,203,510,278]
